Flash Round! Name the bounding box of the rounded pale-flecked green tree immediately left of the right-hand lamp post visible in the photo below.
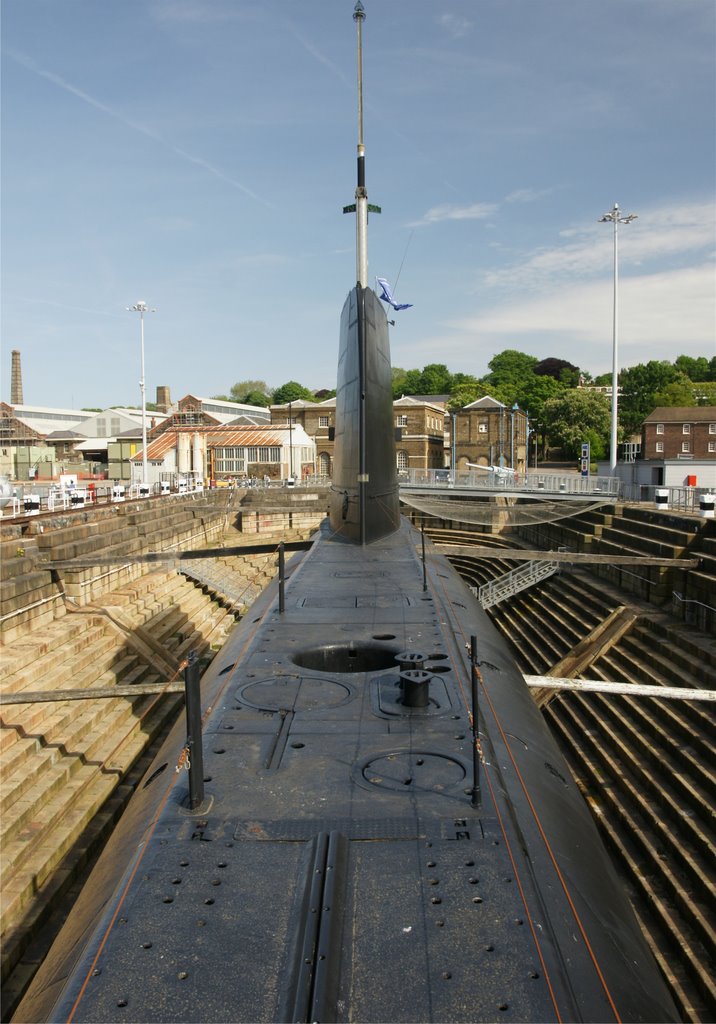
[543,388,612,459]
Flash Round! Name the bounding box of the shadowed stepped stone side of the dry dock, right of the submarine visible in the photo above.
[435,509,716,1021]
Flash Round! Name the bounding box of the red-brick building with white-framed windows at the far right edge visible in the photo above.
[641,406,716,461]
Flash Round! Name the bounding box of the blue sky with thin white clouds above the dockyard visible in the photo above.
[0,0,716,408]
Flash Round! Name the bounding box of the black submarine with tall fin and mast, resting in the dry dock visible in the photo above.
[13,0,679,1022]
